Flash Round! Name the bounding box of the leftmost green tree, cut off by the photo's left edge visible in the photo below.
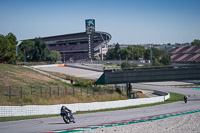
[0,33,18,63]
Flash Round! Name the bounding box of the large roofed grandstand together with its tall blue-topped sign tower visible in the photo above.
[27,19,112,62]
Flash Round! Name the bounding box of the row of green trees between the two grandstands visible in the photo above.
[106,43,171,66]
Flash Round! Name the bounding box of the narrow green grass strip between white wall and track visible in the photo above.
[0,93,183,122]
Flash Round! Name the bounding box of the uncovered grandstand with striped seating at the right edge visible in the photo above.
[168,46,200,64]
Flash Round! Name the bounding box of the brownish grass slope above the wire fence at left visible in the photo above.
[0,64,66,89]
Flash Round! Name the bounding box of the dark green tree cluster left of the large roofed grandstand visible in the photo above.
[0,33,61,63]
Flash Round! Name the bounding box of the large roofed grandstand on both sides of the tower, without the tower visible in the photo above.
[37,31,111,62]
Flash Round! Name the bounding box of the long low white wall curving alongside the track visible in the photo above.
[0,93,170,117]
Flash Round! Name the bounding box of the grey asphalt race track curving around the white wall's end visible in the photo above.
[0,84,200,133]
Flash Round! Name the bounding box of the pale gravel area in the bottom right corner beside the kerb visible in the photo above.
[78,112,200,133]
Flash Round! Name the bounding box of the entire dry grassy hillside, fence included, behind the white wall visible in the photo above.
[0,64,126,105]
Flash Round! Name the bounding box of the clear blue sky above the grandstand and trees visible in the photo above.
[0,0,200,44]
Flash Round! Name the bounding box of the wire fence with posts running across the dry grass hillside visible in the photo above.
[0,86,125,99]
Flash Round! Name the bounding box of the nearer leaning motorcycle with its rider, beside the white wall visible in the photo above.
[60,106,75,124]
